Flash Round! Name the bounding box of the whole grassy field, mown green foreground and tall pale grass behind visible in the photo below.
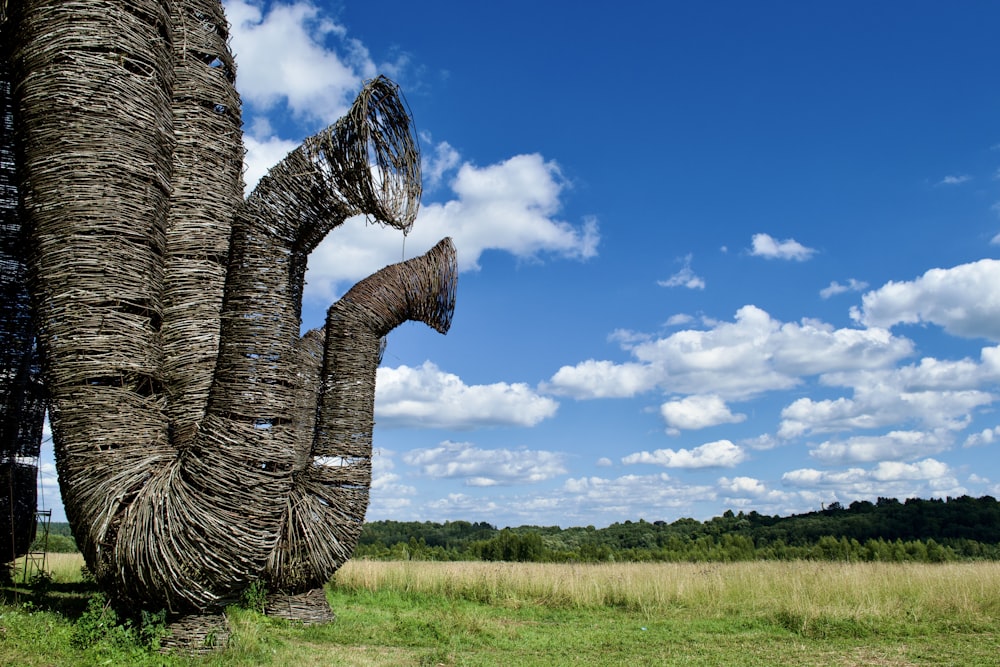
[0,555,1000,667]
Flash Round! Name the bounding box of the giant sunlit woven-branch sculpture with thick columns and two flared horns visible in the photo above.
[4,0,456,632]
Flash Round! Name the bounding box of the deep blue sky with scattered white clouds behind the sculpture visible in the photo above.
[35,0,1000,526]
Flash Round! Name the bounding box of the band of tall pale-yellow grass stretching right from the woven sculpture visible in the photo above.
[334,559,1000,630]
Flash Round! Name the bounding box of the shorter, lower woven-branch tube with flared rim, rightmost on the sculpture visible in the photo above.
[267,238,458,592]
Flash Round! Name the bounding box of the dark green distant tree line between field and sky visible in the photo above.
[355,496,1000,562]
